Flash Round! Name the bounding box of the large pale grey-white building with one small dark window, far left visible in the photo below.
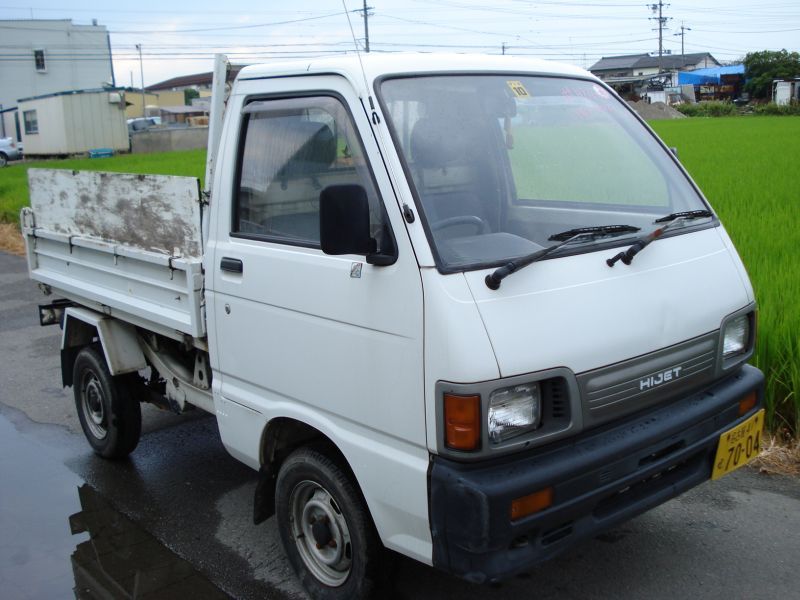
[0,19,114,137]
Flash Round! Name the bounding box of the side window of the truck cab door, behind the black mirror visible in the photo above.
[232,96,392,252]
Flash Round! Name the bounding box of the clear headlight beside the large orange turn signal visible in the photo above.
[489,383,541,444]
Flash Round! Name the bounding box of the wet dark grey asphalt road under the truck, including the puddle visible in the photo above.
[0,252,800,600]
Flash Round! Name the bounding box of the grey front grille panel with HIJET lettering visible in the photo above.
[578,332,719,427]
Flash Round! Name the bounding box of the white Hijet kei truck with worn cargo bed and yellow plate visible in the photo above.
[22,54,764,598]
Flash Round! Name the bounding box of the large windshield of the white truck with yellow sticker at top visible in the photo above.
[381,75,707,271]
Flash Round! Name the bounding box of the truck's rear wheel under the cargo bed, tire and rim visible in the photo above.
[72,346,142,459]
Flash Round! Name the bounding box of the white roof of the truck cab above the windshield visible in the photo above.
[237,52,594,94]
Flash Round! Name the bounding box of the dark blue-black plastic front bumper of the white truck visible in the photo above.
[430,365,764,583]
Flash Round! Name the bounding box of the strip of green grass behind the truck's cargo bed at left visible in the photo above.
[0,150,206,223]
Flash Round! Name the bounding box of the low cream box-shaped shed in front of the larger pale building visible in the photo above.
[18,89,128,156]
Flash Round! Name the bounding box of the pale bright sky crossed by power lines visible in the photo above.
[0,0,800,87]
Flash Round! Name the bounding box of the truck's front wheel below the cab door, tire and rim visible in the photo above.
[275,448,383,600]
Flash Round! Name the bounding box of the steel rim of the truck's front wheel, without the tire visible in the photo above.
[289,481,353,587]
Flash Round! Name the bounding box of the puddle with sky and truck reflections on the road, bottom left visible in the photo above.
[0,415,229,600]
